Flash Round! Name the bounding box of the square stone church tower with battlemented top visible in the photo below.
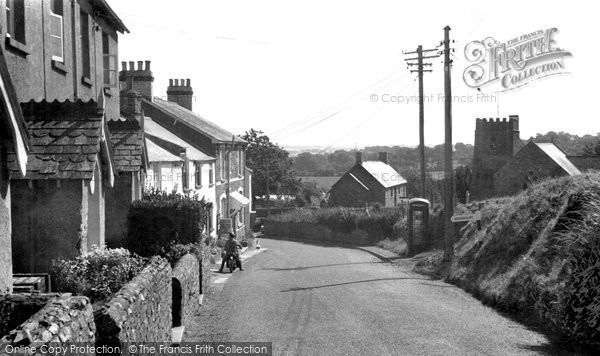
[471,115,523,200]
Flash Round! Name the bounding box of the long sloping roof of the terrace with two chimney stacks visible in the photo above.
[142,98,247,144]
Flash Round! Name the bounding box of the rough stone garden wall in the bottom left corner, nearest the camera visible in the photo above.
[0,294,96,355]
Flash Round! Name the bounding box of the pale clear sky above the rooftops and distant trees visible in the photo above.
[109,0,600,149]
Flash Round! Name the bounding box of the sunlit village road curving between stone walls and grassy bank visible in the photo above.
[186,239,564,355]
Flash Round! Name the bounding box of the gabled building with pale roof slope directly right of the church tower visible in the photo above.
[494,141,581,195]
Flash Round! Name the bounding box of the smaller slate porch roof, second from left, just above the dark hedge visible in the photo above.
[108,120,147,172]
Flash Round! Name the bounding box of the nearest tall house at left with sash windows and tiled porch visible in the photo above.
[0,0,127,272]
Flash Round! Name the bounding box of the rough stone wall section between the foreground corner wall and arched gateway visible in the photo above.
[95,257,172,352]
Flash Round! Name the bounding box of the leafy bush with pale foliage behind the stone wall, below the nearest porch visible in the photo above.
[51,247,147,302]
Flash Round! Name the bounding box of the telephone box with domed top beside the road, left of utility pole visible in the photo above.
[407,198,430,256]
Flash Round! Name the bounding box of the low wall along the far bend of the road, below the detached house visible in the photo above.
[264,220,369,245]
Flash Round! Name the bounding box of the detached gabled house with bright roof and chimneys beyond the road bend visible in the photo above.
[329,152,407,208]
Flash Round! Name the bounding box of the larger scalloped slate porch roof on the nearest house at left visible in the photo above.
[8,101,109,179]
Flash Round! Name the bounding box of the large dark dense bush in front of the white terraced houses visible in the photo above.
[125,190,210,257]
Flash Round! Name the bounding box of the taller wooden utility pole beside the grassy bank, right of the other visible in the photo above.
[444,26,454,261]
